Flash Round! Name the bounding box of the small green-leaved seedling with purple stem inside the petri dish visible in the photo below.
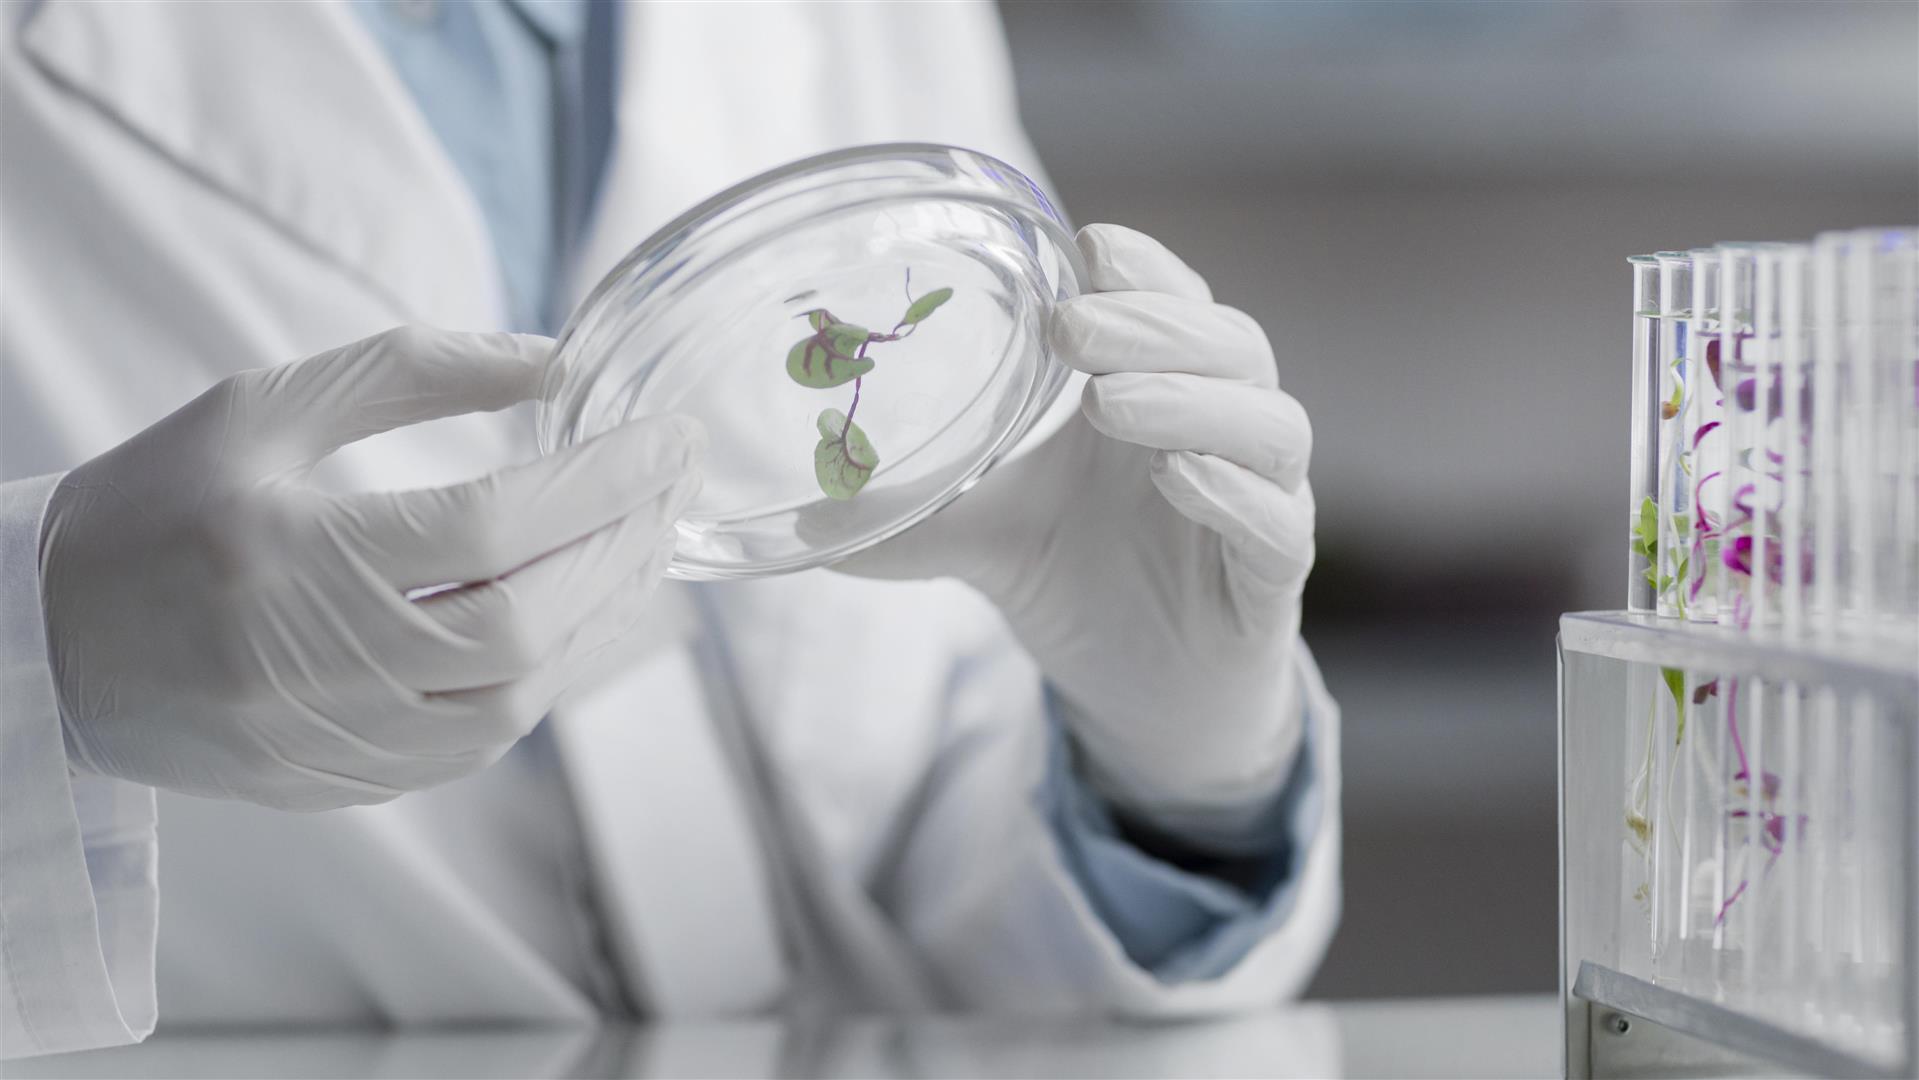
[787,270,954,501]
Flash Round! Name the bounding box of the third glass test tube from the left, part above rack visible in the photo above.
[1681,247,1727,622]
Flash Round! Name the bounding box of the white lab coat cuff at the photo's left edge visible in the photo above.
[0,476,159,1057]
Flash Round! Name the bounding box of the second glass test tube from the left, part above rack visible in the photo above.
[1654,251,1694,618]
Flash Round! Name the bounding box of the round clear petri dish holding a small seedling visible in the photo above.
[539,144,1086,581]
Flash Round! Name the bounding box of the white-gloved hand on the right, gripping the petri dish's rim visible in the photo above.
[841,224,1313,831]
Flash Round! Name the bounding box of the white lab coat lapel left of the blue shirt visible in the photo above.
[19,0,505,328]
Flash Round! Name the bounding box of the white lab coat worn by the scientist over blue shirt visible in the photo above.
[0,0,1339,1055]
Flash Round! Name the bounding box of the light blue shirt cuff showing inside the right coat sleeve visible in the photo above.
[1040,694,1322,982]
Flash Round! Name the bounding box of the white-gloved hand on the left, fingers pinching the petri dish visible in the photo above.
[40,328,704,810]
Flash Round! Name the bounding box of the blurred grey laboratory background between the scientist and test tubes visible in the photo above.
[1002,0,1919,998]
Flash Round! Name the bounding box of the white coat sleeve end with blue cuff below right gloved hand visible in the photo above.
[890,633,1339,1017]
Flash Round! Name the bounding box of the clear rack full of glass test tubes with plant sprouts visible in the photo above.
[1560,228,1919,1076]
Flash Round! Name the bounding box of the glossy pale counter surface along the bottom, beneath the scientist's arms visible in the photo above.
[0,996,1560,1080]
